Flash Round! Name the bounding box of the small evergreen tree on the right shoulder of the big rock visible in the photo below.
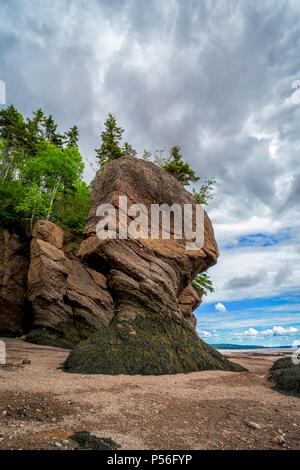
[162,145,199,186]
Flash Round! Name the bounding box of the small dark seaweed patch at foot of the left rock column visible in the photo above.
[26,320,95,349]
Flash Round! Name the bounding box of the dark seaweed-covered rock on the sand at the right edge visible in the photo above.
[269,357,300,396]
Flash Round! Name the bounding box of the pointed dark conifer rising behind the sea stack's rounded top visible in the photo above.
[95,113,124,166]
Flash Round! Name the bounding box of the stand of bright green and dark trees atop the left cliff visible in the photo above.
[0,106,91,239]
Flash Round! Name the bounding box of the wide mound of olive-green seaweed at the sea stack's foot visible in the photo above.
[63,317,246,375]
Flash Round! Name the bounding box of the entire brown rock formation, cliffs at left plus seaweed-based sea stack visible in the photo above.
[0,157,246,374]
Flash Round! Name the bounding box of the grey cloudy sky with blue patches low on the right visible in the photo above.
[0,0,300,345]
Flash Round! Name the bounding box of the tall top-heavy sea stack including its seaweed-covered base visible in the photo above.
[64,157,242,374]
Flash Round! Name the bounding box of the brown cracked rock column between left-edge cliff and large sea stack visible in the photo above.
[28,220,113,344]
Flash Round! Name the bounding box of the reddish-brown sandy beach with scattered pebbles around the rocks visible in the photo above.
[0,338,300,450]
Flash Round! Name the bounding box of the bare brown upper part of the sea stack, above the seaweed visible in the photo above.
[79,156,218,324]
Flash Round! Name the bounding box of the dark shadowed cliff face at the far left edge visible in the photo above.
[0,230,29,336]
